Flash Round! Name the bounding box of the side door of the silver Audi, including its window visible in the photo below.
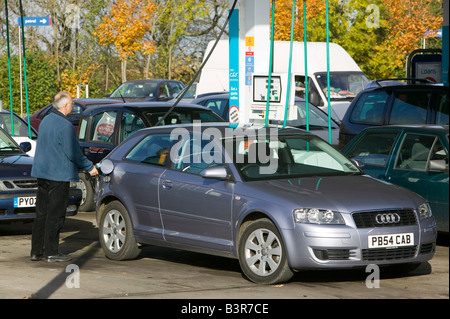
[159,136,234,252]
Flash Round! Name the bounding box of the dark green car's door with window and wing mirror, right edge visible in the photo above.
[387,133,449,231]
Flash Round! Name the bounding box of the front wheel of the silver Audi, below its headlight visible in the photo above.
[239,218,294,285]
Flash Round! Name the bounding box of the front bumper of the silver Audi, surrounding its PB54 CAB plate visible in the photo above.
[283,217,437,270]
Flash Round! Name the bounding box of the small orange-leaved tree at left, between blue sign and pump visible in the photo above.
[94,0,156,82]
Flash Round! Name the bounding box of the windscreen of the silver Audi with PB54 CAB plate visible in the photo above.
[225,135,361,181]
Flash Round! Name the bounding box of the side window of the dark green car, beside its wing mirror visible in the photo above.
[395,134,442,171]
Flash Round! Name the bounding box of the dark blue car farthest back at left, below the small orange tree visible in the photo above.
[106,79,185,101]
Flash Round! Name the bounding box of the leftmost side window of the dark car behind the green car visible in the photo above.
[350,91,389,125]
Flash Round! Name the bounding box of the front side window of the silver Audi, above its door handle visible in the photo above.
[171,136,223,175]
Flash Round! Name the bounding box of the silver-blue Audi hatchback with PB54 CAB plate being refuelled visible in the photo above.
[96,123,437,284]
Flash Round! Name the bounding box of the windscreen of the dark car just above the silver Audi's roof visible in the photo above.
[144,108,224,126]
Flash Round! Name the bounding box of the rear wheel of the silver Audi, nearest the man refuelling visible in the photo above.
[98,201,140,260]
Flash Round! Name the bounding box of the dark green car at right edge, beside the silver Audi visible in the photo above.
[342,125,449,233]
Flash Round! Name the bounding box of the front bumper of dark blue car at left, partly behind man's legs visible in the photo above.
[0,188,82,222]
